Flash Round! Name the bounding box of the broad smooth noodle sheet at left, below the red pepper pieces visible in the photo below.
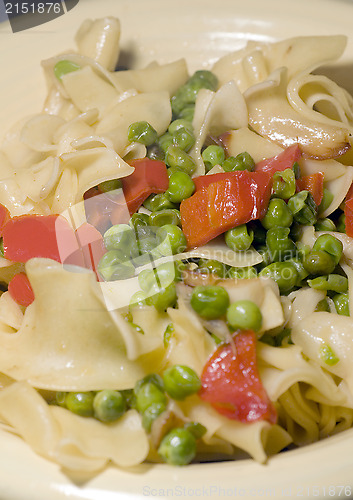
[0,259,168,391]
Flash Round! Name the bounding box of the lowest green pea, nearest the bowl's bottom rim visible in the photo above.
[158,427,196,465]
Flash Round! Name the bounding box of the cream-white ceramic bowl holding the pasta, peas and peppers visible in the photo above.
[0,0,353,500]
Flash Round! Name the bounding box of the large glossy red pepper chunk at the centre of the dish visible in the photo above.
[180,170,272,248]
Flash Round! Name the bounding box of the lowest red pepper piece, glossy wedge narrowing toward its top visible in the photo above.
[199,330,277,424]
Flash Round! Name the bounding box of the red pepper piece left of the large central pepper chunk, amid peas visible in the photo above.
[121,158,169,215]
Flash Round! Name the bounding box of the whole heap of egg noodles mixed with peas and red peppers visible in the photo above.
[0,18,353,472]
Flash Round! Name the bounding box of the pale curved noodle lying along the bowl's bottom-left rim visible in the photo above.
[0,381,149,472]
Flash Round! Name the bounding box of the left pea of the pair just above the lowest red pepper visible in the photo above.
[190,285,229,319]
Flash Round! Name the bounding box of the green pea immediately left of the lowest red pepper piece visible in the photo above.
[163,365,201,401]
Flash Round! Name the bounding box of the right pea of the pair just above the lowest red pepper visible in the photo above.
[226,300,262,332]
